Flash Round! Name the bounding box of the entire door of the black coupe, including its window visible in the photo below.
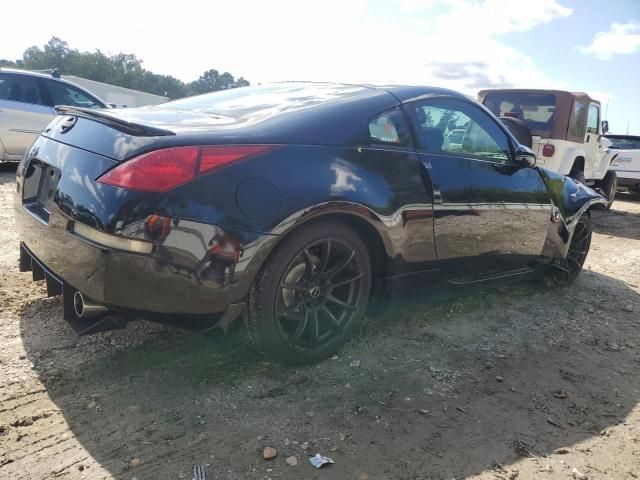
[405,97,551,283]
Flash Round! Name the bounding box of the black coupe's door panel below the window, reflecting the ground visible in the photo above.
[420,154,551,282]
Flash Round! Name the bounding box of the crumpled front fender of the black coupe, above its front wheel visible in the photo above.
[539,168,607,258]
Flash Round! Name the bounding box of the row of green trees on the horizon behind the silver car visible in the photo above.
[0,37,249,99]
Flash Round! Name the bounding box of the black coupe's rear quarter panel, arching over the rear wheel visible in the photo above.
[165,145,436,275]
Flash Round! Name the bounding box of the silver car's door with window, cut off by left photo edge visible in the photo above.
[0,72,55,156]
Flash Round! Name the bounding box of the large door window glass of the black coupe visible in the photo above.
[409,98,510,162]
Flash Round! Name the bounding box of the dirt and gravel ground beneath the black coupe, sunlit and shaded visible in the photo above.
[0,162,640,480]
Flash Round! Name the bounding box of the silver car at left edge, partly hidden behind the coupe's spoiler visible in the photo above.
[0,68,107,162]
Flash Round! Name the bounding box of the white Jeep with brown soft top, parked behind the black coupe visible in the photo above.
[478,89,617,207]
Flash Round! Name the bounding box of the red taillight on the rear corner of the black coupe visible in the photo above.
[98,145,274,192]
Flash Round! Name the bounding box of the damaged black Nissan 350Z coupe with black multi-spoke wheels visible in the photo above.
[15,83,605,363]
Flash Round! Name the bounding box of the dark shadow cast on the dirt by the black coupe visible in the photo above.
[21,264,640,480]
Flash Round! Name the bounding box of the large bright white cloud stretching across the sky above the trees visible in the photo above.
[0,0,571,95]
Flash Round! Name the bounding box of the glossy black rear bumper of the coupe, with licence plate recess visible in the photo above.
[14,133,277,330]
